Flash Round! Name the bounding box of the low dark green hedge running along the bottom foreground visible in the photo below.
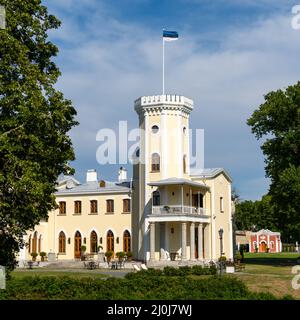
[0,276,284,300]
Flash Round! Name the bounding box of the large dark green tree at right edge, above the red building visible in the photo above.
[248,82,300,241]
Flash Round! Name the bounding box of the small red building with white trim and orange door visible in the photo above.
[249,229,282,253]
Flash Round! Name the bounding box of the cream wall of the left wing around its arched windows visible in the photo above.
[27,193,131,259]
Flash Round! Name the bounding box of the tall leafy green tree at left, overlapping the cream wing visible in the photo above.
[0,0,77,270]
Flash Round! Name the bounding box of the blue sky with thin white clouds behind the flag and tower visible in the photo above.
[43,0,300,200]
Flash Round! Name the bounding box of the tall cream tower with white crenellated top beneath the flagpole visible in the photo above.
[132,95,210,260]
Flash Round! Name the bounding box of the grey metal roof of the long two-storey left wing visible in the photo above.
[55,181,130,195]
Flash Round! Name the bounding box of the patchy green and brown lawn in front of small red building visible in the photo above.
[232,252,300,299]
